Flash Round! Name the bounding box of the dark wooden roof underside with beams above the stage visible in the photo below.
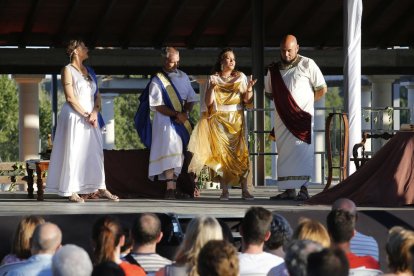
[0,0,414,49]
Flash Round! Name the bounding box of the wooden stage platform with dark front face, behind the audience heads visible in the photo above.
[0,186,414,269]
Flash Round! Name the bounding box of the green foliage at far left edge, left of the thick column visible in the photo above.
[0,75,19,162]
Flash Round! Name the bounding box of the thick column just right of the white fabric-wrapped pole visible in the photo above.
[368,75,399,152]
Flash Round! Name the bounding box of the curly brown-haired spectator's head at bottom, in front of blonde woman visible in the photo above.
[197,240,239,276]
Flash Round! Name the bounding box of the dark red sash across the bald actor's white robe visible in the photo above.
[269,64,312,144]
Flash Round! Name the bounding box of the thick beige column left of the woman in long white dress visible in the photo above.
[13,75,44,161]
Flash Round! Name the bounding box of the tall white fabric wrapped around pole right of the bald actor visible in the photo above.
[344,0,362,175]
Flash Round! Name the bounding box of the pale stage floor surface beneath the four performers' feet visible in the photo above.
[0,187,406,218]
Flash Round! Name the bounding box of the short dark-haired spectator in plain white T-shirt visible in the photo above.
[239,207,285,276]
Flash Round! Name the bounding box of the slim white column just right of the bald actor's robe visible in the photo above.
[312,95,325,184]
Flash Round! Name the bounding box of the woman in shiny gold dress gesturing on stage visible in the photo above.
[188,48,256,200]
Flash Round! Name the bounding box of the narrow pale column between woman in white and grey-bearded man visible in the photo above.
[101,93,118,150]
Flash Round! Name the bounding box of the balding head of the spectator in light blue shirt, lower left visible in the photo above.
[31,222,62,255]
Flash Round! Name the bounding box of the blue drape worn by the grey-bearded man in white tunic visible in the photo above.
[134,72,190,149]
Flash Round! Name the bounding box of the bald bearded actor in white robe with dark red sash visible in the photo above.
[265,35,327,200]
